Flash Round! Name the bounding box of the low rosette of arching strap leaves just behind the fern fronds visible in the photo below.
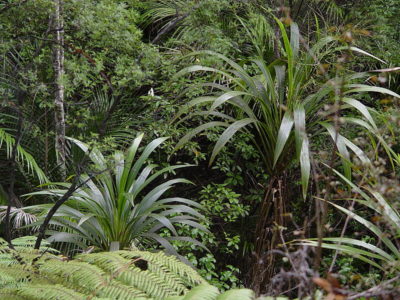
[25,135,206,254]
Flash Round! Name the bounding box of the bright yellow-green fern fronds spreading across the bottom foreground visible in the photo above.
[0,237,284,300]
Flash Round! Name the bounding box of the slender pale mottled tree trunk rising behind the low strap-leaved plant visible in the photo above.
[53,0,66,179]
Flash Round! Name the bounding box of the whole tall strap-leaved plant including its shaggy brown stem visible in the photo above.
[175,20,400,290]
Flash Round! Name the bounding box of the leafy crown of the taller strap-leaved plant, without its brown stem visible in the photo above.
[176,20,400,196]
